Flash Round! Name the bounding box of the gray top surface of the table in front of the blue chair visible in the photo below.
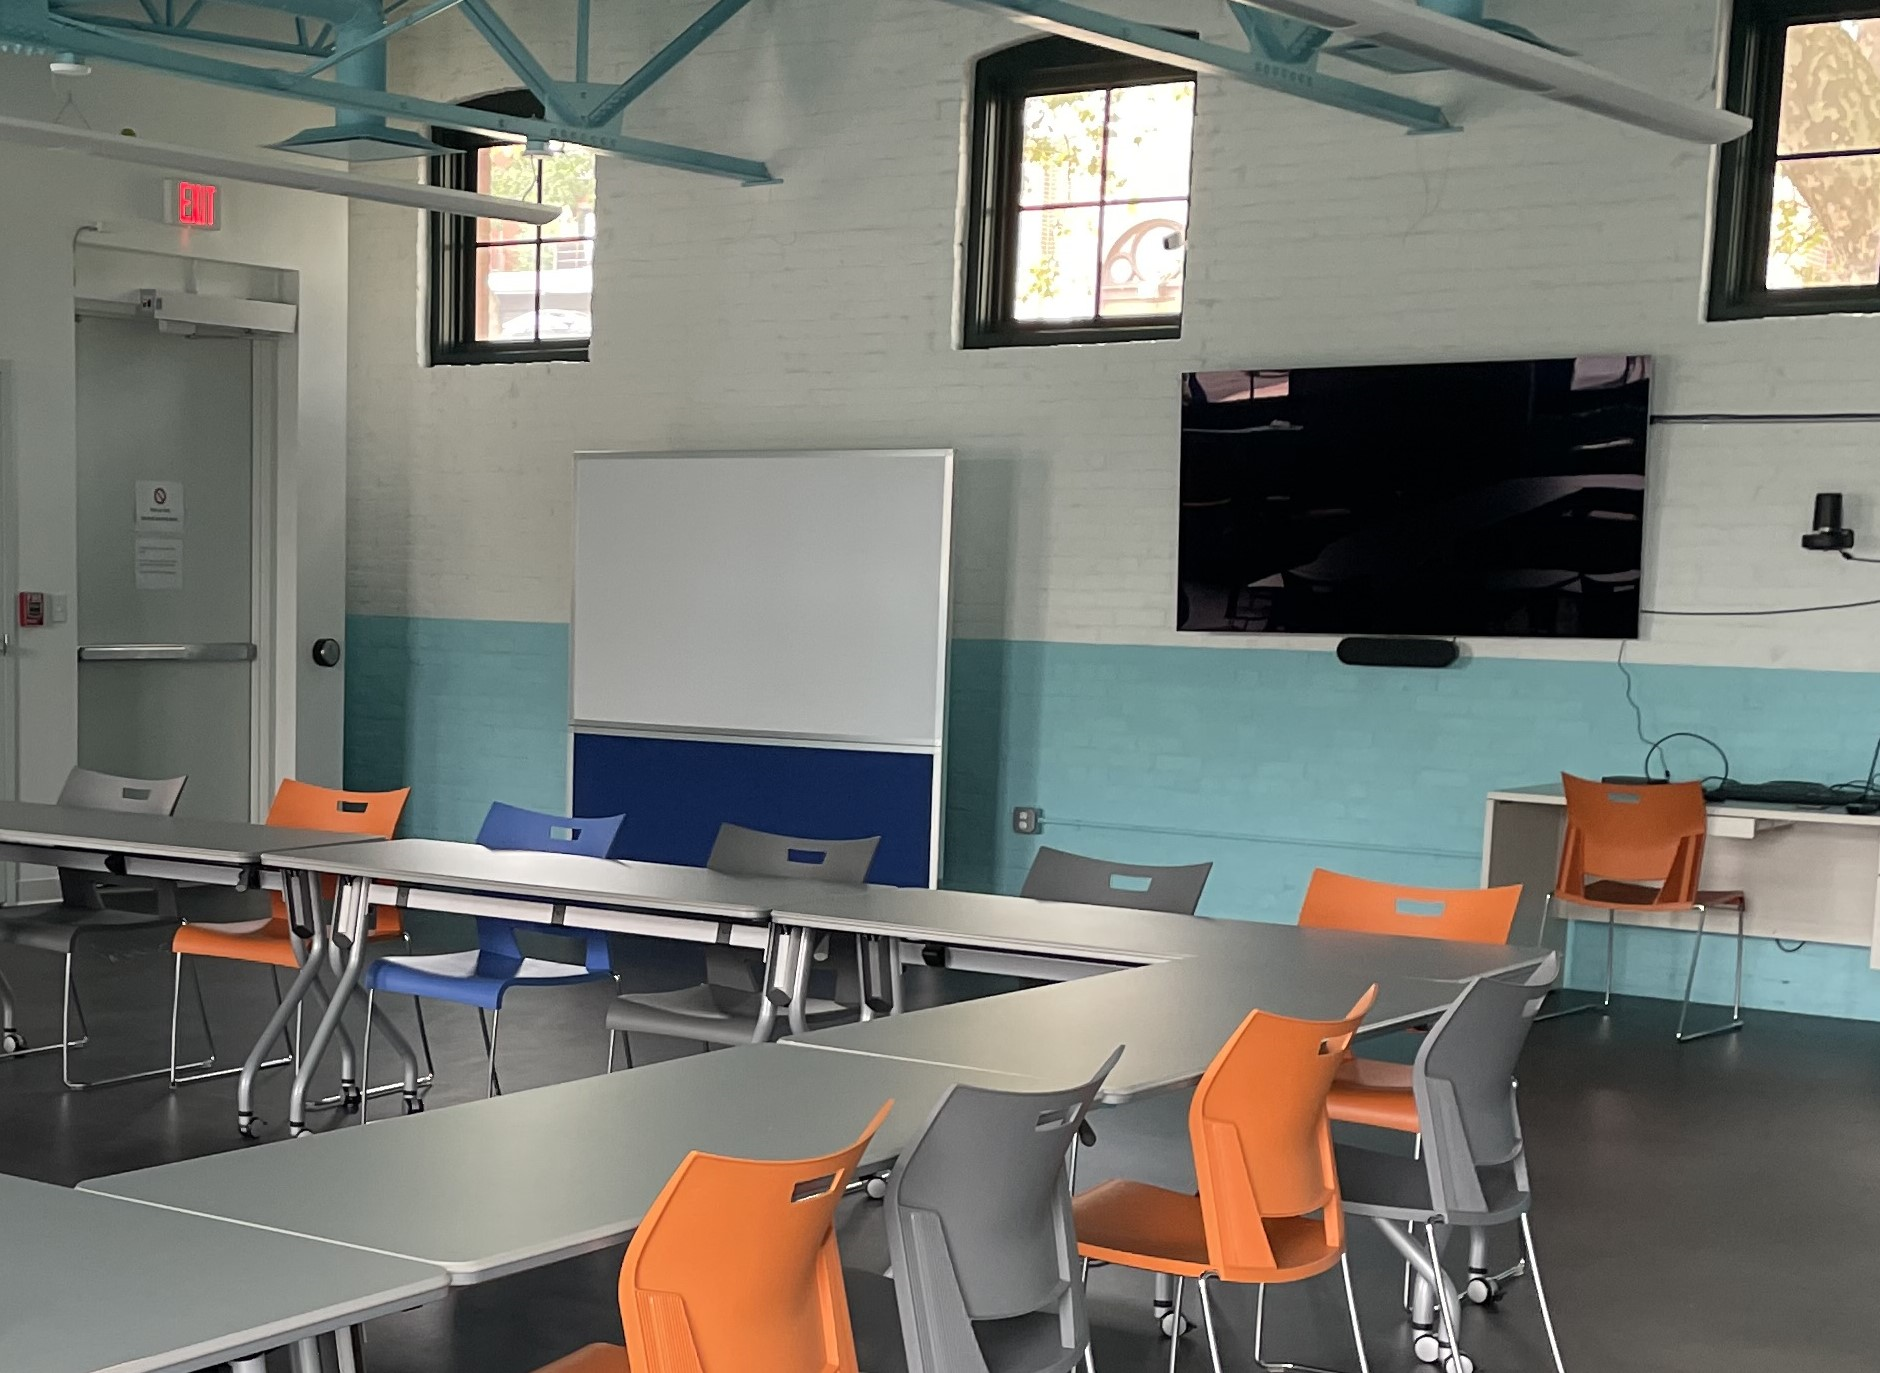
[265,835,778,923]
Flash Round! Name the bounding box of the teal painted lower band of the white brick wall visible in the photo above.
[346,615,1880,1019]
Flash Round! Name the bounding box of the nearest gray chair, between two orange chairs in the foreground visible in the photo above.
[844,1048,1122,1373]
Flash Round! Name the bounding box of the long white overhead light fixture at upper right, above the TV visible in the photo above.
[1231,0,1750,143]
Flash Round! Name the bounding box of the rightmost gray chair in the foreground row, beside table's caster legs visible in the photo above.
[1338,954,1564,1373]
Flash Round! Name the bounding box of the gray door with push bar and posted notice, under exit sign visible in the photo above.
[75,314,271,820]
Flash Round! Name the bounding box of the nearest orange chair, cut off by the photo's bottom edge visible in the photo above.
[538,1102,893,1373]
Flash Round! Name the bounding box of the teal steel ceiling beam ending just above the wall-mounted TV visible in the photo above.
[948,0,1457,134]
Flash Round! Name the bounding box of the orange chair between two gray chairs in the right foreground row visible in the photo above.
[1073,987,1378,1369]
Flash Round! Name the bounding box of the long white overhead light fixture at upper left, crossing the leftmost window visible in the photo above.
[0,115,562,224]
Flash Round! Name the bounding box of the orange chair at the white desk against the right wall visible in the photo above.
[1538,773,1748,1044]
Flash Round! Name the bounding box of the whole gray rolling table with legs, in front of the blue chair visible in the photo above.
[250,835,807,1134]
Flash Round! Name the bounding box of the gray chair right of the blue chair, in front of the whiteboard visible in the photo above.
[607,824,882,1072]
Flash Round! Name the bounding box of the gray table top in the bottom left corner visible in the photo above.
[0,1176,446,1373]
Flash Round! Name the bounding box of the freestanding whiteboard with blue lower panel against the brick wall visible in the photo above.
[570,450,953,886]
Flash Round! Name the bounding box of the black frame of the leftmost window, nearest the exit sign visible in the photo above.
[427,90,590,367]
